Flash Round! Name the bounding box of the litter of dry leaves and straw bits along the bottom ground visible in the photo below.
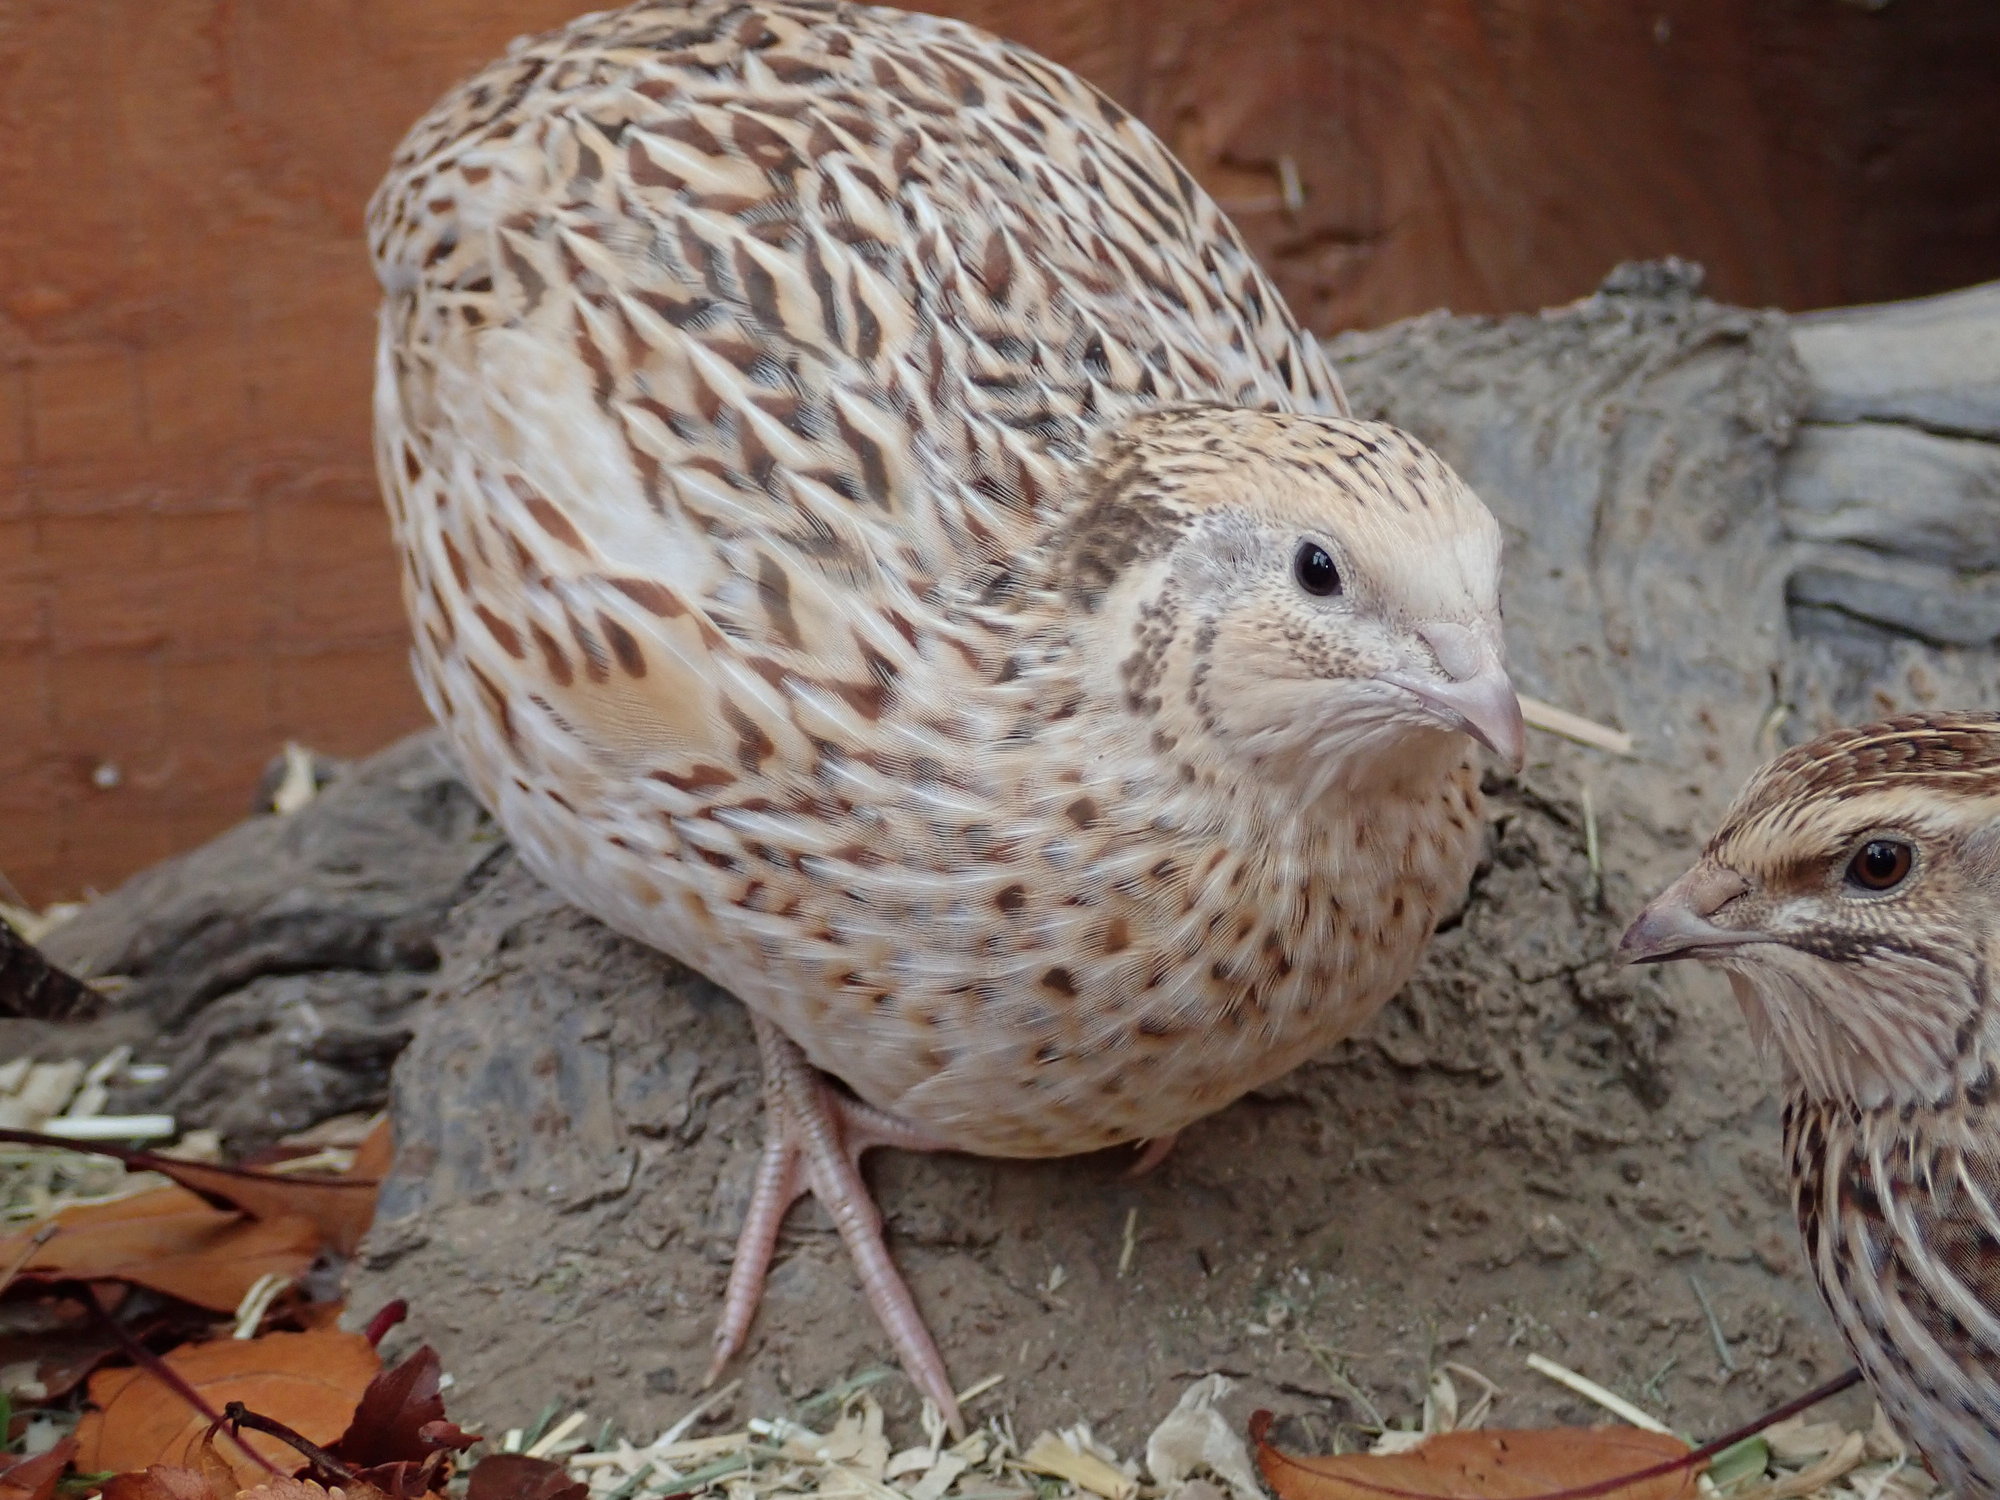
[0,1056,1934,1500]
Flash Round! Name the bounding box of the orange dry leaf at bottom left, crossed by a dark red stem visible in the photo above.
[76,1330,382,1488]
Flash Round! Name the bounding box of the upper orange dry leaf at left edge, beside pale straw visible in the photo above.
[0,1188,320,1312]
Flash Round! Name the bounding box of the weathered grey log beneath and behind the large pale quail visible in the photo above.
[23,266,2000,1450]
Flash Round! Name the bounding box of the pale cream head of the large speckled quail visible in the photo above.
[1052,406,1522,798]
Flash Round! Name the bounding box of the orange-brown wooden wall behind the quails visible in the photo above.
[0,0,2000,902]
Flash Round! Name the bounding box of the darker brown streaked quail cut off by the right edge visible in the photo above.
[1622,714,2000,1500]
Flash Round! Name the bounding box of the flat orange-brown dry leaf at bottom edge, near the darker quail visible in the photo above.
[1250,1412,1694,1500]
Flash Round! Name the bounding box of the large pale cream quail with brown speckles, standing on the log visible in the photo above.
[370,0,1522,1422]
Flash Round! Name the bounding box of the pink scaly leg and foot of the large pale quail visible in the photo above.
[702,1016,964,1436]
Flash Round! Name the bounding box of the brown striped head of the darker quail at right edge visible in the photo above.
[1622,712,2000,1108]
